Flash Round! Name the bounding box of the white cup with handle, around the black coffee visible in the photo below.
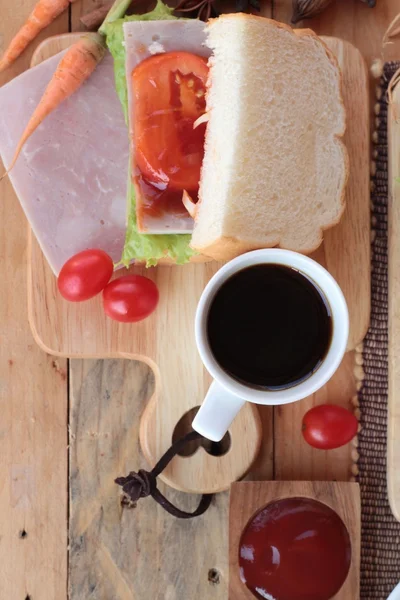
[192,248,349,442]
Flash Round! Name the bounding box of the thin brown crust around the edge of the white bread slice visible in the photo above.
[195,13,350,261]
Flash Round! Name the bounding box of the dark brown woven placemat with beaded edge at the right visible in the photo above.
[358,62,400,600]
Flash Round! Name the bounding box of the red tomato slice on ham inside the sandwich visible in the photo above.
[132,52,208,190]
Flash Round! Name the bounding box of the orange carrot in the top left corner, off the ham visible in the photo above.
[0,0,76,72]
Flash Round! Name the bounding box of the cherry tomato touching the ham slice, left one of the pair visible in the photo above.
[57,249,114,302]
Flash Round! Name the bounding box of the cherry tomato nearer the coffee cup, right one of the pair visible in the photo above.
[103,275,159,323]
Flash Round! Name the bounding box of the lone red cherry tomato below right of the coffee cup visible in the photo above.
[302,404,358,450]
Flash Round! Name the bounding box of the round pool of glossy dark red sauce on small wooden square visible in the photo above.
[239,498,351,600]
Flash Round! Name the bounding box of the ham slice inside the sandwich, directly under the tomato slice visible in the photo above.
[123,20,211,234]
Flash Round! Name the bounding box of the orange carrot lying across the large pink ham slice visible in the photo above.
[0,33,106,181]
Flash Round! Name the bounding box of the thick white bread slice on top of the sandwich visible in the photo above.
[192,14,348,260]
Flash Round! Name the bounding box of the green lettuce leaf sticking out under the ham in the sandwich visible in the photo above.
[103,0,195,266]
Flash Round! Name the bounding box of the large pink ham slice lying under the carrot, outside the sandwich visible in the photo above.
[0,53,129,274]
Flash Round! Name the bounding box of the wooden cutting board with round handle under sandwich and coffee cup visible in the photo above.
[28,34,370,491]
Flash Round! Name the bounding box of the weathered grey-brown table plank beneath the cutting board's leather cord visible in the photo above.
[70,360,229,600]
